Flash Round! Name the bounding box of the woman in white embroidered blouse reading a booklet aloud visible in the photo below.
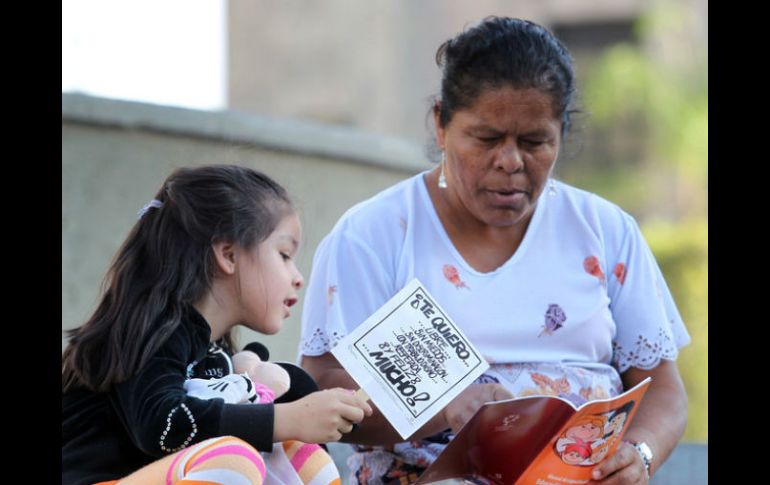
[300,17,689,485]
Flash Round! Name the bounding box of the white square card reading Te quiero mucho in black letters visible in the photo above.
[331,278,489,439]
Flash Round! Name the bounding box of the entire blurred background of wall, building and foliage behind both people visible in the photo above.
[62,0,708,441]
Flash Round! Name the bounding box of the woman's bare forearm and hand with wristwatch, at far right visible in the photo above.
[594,360,687,485]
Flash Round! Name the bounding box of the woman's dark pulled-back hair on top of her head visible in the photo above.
[434,17,577,136]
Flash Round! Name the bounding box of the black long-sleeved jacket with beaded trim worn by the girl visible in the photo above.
[62,308,274,485]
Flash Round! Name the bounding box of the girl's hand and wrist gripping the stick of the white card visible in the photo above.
[273,387,372,443]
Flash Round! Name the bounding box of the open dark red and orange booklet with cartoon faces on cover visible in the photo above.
[416,377,652,485]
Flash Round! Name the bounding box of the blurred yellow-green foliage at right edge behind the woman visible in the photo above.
[560,3,708,441]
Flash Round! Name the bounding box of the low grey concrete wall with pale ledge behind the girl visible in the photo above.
[62,94,430,361]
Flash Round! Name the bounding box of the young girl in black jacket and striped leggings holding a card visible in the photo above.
[62,165,371,485]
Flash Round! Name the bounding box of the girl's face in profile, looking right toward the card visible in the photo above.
[237,212,305,335]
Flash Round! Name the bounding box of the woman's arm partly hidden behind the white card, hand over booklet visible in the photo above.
[301,352,513,446]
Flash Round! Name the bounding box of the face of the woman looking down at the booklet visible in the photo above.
[435,87,561,228]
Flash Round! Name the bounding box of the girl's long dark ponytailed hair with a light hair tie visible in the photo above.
[62,165,294,392]
